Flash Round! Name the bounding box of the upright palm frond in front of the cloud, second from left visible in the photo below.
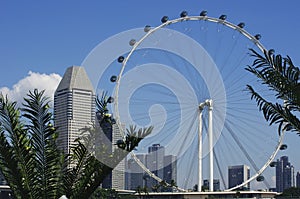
[22,89,61,199]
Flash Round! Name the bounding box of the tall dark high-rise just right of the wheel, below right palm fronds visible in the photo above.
[276,156,294,192]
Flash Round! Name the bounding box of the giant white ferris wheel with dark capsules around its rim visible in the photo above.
[83,11,284,191]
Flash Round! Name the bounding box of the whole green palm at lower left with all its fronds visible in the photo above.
[0,90,153,199]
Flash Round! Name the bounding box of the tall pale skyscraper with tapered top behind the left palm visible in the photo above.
[54,66,95,153]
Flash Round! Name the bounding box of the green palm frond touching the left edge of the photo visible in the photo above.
[0,95,35,198]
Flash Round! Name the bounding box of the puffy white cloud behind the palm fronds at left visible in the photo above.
[0,71,62,104]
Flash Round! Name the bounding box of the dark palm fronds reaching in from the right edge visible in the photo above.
[246,49,300,134]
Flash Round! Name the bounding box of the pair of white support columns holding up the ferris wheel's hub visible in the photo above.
[198,99,214,192]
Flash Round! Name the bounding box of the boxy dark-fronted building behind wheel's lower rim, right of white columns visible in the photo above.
[228,165,250,190]
